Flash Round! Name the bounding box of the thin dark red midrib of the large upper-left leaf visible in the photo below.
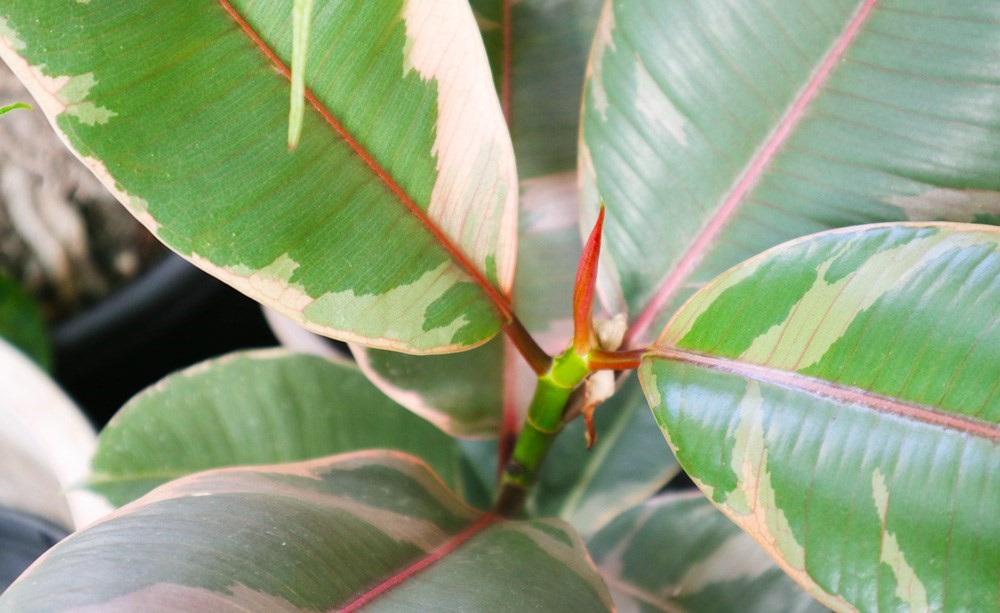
[219,0,513,322]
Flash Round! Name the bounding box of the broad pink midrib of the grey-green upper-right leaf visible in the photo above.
[625,0,878,347]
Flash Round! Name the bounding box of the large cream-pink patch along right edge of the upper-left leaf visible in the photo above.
[403,0,517,293]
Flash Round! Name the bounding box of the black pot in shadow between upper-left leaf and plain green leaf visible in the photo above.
[53,254,276,428]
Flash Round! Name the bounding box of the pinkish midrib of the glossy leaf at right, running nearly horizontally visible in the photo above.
[647,347,1000,441]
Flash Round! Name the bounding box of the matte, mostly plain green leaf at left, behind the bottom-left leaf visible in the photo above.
[88,350,488,505]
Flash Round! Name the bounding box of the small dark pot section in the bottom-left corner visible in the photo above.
[0,507,68,592]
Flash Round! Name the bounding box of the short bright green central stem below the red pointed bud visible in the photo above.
[494,347,589,517]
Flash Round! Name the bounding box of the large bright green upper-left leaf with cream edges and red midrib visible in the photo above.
[0,0,517,353]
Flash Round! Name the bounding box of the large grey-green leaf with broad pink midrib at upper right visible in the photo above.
[580,0,1000,347]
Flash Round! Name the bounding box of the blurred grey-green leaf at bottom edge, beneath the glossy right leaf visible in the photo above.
[587,493,827,613]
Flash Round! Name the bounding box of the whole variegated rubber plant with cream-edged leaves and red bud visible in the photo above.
[0,0,1000,611]
